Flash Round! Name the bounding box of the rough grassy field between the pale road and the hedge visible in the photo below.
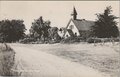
[21,43,120,77]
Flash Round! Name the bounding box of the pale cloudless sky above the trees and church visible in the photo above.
[0,1,120,33]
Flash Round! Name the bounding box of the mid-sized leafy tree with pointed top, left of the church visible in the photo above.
[30,16,51,40]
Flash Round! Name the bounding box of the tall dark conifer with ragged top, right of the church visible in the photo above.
[92,6,119,38]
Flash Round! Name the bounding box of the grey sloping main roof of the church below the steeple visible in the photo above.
[72,19,95,31]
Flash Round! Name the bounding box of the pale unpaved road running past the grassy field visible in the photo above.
[11,45,109,77]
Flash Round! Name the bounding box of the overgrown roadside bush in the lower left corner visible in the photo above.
[0,44,15,76]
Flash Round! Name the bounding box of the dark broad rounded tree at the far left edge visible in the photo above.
[0,20,26,42]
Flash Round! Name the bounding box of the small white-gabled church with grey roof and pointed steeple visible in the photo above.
[63,7,95,38]
